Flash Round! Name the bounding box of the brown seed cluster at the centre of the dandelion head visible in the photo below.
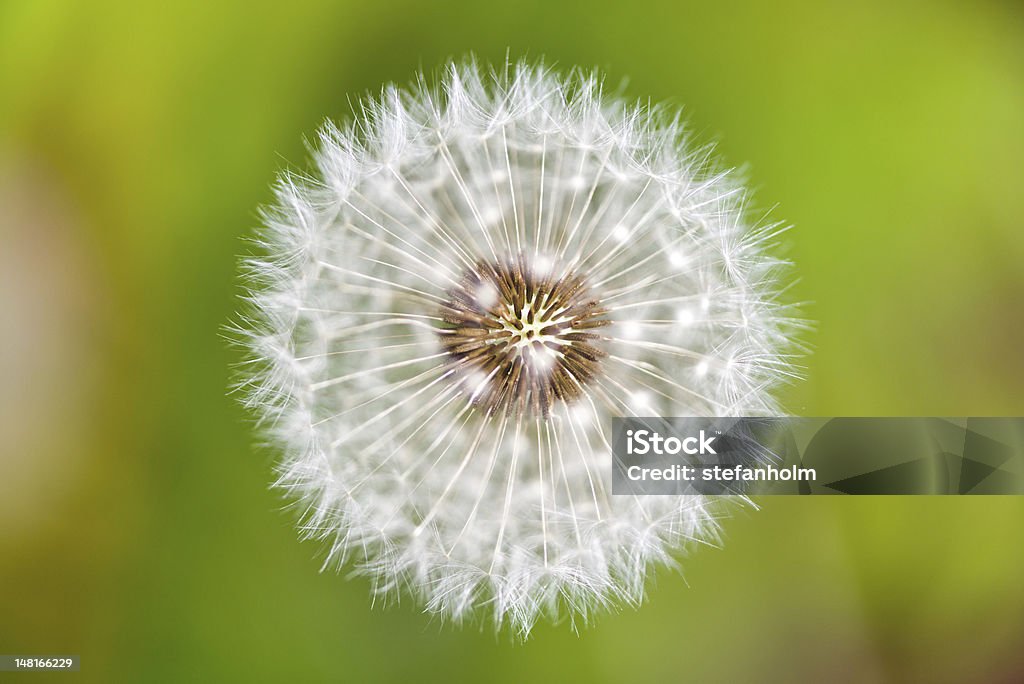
[438,255,610,418]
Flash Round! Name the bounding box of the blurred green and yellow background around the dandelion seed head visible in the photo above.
[0,0,1024,683]
